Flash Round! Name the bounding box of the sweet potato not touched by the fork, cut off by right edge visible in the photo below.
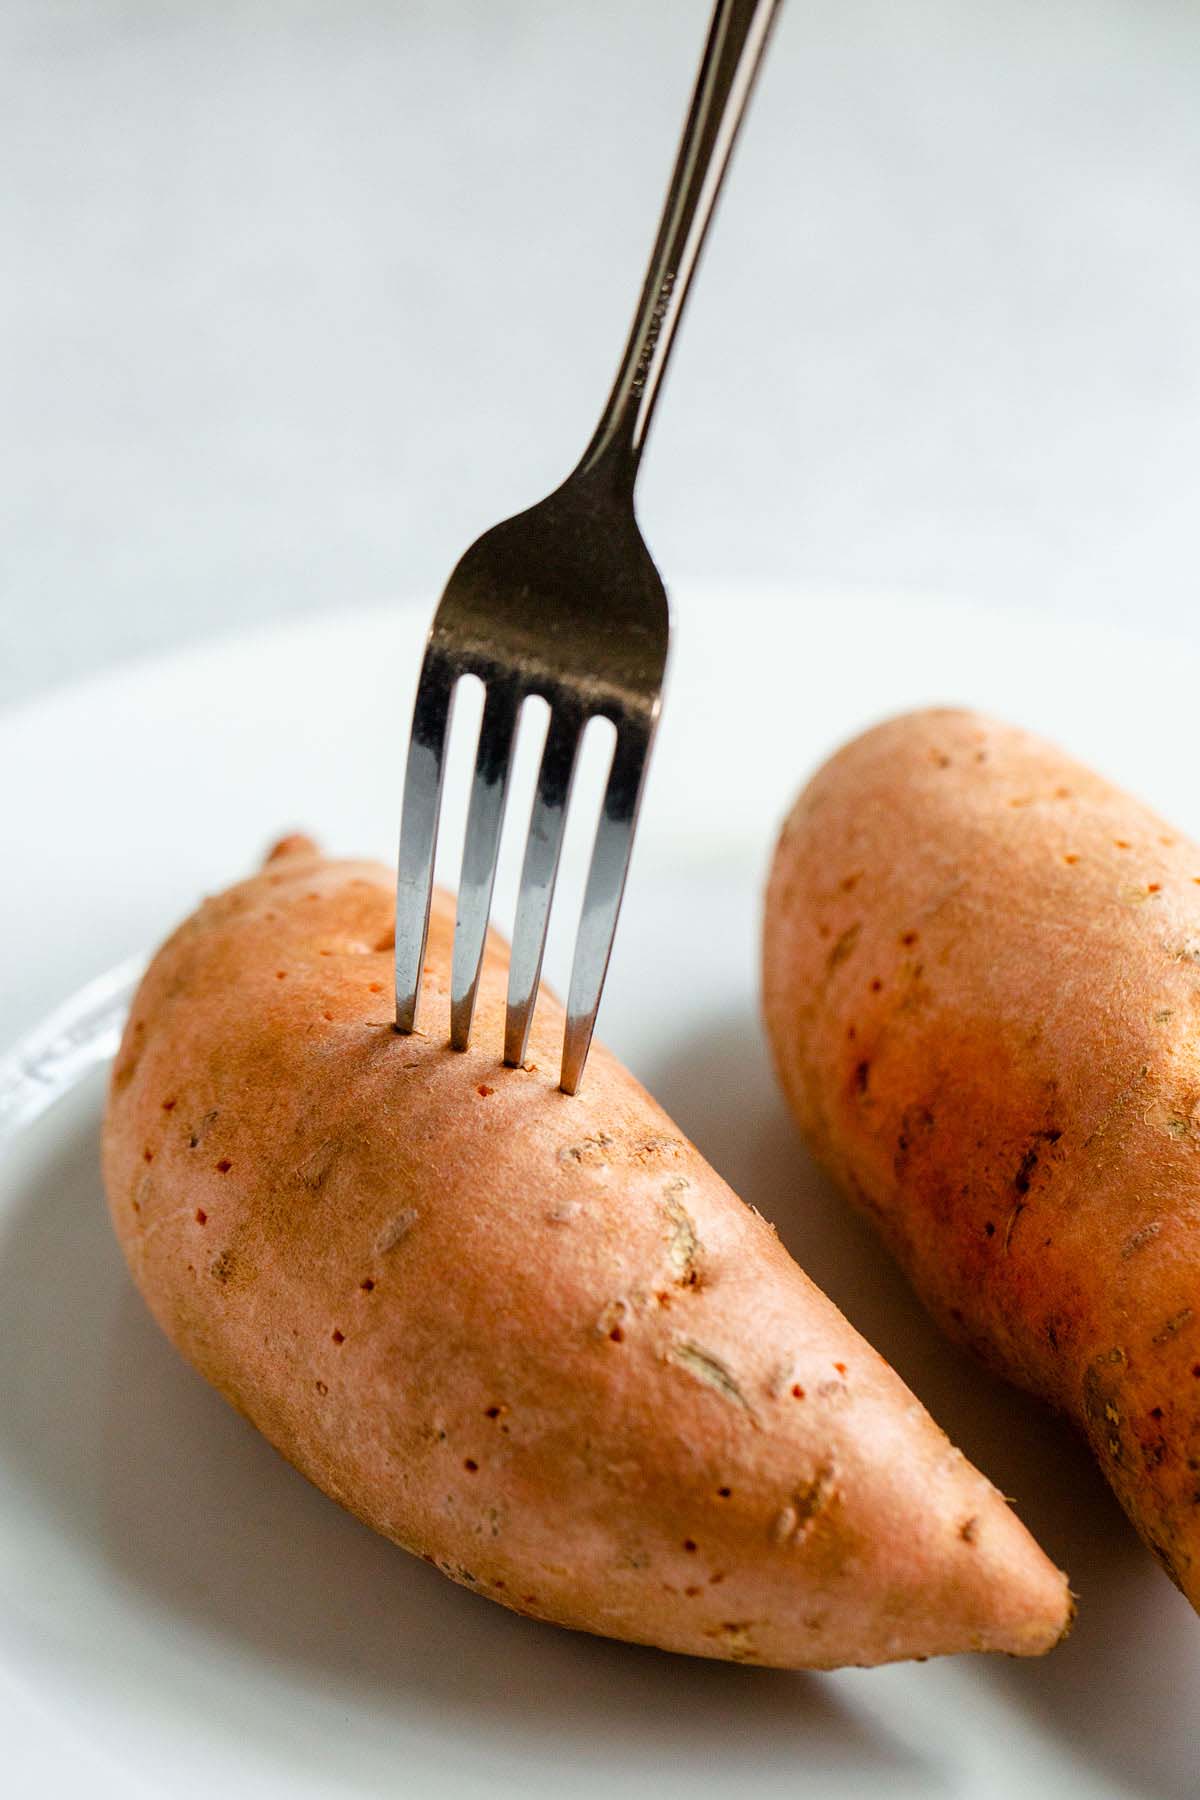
[763,711,1200,1606]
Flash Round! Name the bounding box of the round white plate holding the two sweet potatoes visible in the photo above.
[0,592,1200,1800]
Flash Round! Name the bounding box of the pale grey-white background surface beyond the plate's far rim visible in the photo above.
[0,0,1200,702]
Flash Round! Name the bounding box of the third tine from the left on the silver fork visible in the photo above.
[504,704,583,1067]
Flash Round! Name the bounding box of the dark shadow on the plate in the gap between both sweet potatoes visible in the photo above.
[639,1010,1200,1800]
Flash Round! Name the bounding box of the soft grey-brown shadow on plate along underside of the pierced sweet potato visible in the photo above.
[0,1072,941,1795]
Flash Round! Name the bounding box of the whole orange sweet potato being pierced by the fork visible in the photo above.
[104,841,1070,1667]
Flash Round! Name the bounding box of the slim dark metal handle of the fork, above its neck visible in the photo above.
[576,0,781,495]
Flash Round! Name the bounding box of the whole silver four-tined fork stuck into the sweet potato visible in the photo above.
[396,0,779,1094]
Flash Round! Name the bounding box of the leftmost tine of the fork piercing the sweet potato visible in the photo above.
[396,646,457,1031]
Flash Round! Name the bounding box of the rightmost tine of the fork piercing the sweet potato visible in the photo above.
[560,722,653,1094]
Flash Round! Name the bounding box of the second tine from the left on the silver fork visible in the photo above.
[450,679,520,1049]
